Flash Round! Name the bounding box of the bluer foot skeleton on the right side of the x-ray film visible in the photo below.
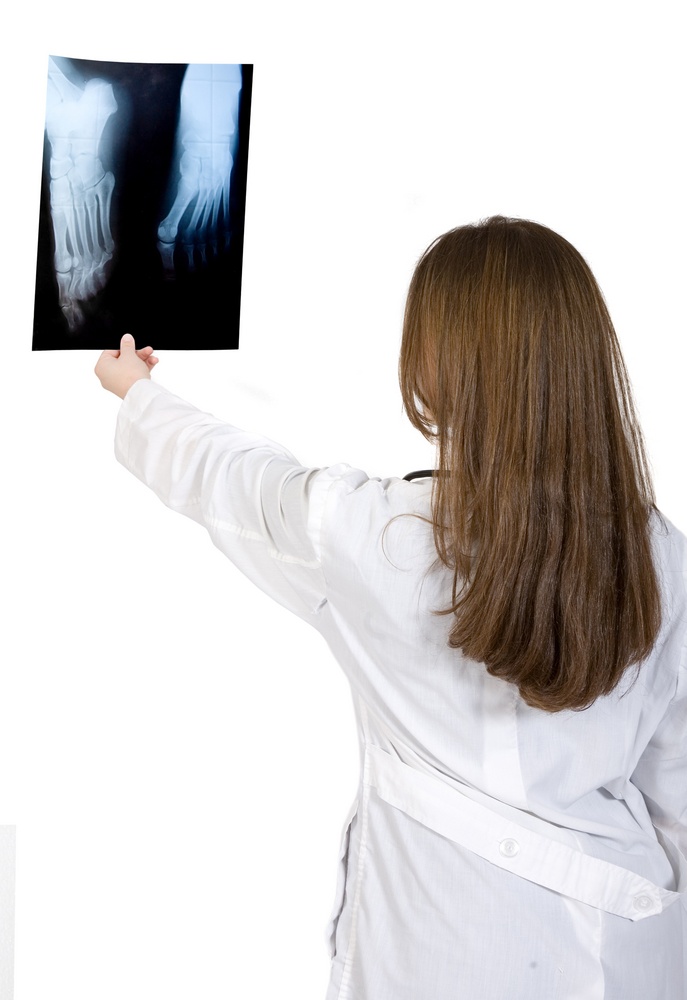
[157,64,241,275]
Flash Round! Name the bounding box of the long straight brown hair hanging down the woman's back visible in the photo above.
[400,216,661,712]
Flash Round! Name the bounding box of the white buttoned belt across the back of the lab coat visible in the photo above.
[363,744,682,920]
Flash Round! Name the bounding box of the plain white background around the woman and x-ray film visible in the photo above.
[0,0,687,1000]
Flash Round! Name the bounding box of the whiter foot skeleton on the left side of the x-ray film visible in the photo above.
[45,58,117,331]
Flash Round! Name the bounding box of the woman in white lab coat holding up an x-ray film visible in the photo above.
[96,217,687,1000]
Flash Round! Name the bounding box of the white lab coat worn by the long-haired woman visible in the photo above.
[116,380,687,1000]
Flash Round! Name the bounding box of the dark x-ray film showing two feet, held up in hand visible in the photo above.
[33,56,253,351]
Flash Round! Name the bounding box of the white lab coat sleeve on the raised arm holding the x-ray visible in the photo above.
[115,379,336,619]
